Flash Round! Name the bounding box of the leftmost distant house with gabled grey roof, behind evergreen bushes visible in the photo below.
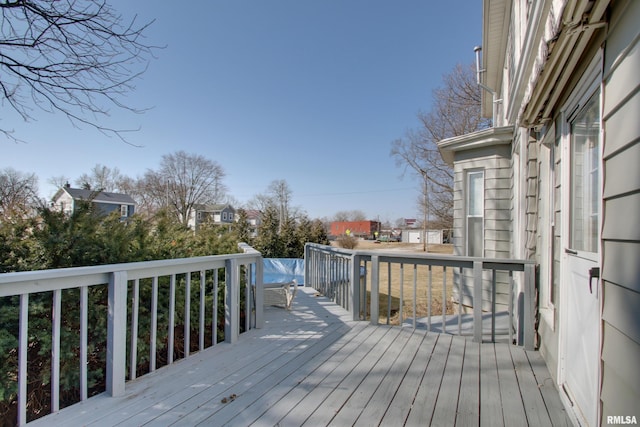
[51,184,136,219]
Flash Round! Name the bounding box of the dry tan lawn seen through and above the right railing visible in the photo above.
[336,241,453,324]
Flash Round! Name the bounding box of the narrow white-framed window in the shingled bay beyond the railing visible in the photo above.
[466,171,484,257]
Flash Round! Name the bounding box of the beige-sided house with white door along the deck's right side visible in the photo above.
[440,0,640,426]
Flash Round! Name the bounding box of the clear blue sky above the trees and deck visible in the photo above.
[0,0,482,222]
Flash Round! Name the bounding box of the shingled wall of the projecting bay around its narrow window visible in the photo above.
[453,145,511,311]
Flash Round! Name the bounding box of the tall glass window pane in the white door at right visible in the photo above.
[569,93,600,253]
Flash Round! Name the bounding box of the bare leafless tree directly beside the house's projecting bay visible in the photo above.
[391,64,491,232]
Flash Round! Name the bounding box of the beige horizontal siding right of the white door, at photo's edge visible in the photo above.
[601,0,640,425]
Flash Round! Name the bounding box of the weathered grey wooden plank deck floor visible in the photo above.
[30,288,571,426]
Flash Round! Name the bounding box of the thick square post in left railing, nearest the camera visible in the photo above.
[106,271,127,397]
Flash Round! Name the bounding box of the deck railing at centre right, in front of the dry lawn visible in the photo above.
[305,243,535,350]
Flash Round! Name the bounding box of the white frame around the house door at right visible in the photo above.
[558,49,604,424]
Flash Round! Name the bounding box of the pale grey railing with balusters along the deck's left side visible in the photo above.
[0,245,263,425]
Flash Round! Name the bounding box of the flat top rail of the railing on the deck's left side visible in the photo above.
[0,253,260,297]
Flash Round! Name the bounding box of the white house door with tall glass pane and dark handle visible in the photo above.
[561,91,602,426]
